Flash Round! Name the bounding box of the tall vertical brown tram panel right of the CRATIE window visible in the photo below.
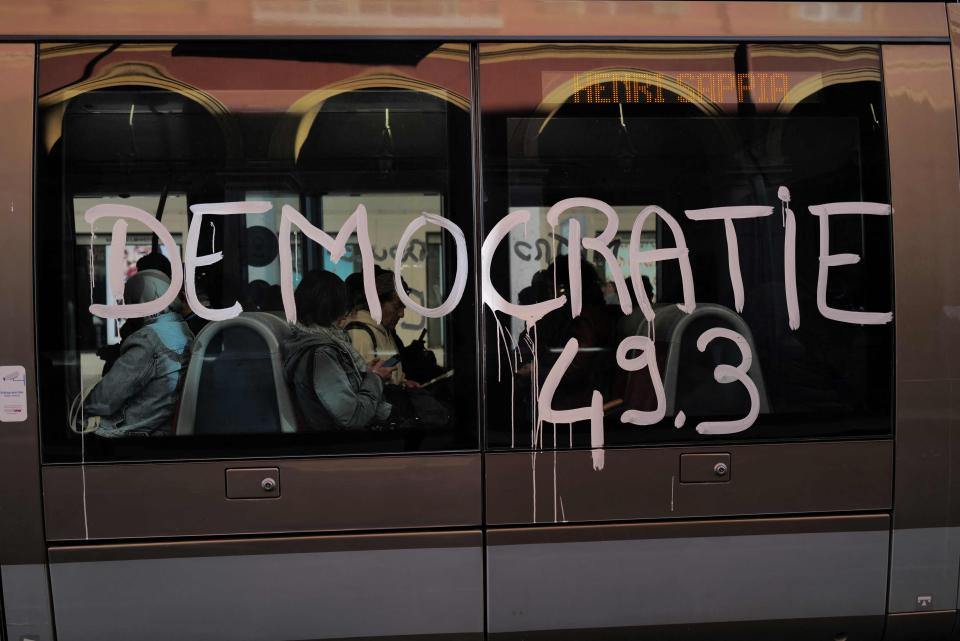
[883,38,960,627]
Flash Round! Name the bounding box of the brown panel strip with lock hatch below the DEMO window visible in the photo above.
[44,454,481,541]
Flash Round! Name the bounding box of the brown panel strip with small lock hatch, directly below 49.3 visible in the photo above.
[486,440,893,525]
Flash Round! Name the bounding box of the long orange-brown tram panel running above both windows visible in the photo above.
[0,0,947,39]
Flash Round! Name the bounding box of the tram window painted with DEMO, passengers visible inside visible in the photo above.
[37,42,479,462]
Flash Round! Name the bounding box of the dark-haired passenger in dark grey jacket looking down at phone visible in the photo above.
[283,270,392,430]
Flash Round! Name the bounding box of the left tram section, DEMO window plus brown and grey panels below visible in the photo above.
[29,42,483,641]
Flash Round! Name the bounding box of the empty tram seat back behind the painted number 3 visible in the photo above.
[636,303,770,416]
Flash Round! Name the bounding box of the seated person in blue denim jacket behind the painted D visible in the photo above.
[83,269,193,437]
